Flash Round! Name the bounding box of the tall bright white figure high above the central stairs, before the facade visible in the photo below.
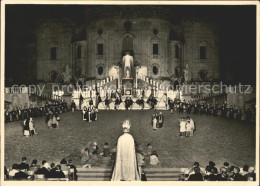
[122,52,134,78]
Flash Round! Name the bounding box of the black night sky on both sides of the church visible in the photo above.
[5,5,256,84]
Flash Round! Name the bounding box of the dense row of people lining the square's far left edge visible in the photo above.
[5,101,68,123]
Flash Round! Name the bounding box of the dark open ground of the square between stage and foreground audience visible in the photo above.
[5,110,255,168]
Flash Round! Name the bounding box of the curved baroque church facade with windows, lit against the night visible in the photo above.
[36,6,219,82]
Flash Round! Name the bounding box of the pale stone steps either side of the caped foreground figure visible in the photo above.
[77,167,183,181]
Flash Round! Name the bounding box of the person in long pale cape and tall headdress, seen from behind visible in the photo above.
[111,120,140,181]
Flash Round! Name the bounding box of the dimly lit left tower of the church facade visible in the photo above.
[36,20,73,81]
